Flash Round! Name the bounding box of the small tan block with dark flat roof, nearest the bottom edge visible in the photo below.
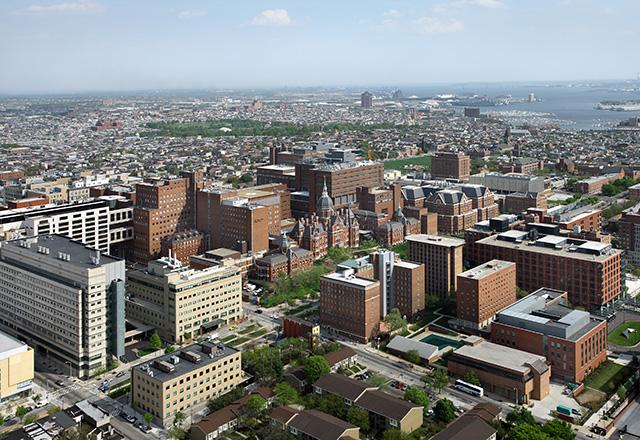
[130,342,243,427]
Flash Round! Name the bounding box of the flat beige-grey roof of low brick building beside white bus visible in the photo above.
[453,341,545,374]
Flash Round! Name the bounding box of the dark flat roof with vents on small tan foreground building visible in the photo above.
[133,342,240,382]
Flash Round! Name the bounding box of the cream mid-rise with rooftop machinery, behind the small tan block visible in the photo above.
[126,254,242,343]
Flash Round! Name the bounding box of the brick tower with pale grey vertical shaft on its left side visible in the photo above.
[369,250,425,318]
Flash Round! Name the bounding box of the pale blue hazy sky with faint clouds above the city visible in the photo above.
[0,0,640,94]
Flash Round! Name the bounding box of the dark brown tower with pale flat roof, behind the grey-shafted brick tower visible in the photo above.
[407,234,464,298]
